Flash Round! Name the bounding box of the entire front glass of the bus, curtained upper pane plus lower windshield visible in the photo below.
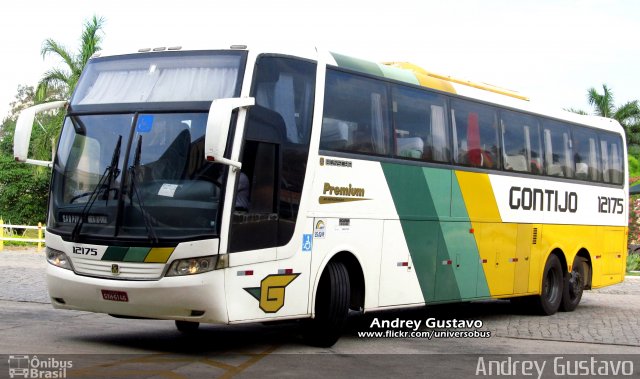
[48,52,242,244]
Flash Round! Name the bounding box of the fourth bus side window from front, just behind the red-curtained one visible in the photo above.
[501,112,542,174]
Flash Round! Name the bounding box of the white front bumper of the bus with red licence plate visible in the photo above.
[47,264,229,324]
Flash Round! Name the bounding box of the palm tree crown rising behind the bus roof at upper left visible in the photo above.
[36,15,105,102]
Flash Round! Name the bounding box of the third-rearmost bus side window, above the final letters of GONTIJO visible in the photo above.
[542,121,573,178]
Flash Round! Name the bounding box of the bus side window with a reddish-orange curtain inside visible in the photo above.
[451,100,498,168]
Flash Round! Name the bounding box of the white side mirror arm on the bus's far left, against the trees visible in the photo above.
[13,100,67,167]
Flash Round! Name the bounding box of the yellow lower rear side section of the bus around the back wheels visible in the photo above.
[456,171,627,298]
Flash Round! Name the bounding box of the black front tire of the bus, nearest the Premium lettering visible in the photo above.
[303,261,351,347]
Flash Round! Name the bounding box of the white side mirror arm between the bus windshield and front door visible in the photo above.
[204,97,256,170]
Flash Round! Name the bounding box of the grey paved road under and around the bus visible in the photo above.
[0,250,640,378]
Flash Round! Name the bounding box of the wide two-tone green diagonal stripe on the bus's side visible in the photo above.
[382,163,489,302]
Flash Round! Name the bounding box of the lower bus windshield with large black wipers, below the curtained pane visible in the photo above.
[49,113,228,242]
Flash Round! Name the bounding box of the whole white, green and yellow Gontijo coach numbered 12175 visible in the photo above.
[15,46,628,346]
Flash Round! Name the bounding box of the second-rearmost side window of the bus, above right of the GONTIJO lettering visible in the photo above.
[573,127,602,181]
